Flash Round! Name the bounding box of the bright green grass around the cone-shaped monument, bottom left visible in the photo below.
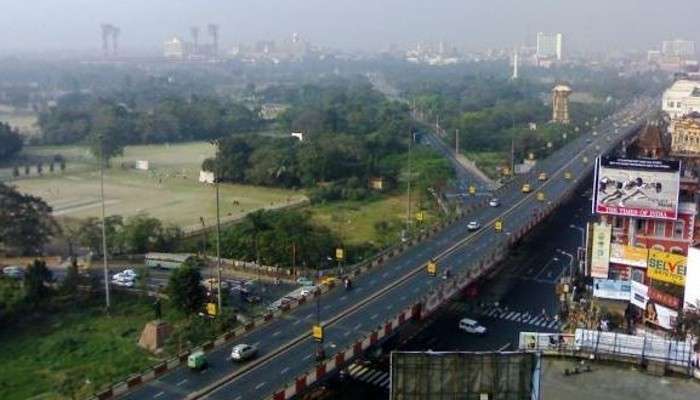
[0,290,174,400]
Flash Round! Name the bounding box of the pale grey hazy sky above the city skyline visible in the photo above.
[0,0,700,52]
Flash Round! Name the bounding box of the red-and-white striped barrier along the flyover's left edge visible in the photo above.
[92,207,475,400]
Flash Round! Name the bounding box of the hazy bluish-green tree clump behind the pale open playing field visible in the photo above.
[39,94,261,150]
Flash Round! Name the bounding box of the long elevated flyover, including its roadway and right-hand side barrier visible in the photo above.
[112,98,657,400]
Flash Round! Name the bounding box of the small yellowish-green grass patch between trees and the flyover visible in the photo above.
[308,195,437,245]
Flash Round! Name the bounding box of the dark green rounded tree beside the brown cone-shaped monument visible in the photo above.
[167,264,206,314]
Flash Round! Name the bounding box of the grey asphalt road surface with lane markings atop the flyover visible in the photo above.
[124,99,656,400]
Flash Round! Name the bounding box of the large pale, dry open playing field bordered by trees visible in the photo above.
[5,142,306,230]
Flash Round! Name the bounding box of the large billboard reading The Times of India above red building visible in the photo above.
[593,157,680,220]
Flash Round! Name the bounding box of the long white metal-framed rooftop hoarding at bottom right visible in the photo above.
[518,329,698,376]
